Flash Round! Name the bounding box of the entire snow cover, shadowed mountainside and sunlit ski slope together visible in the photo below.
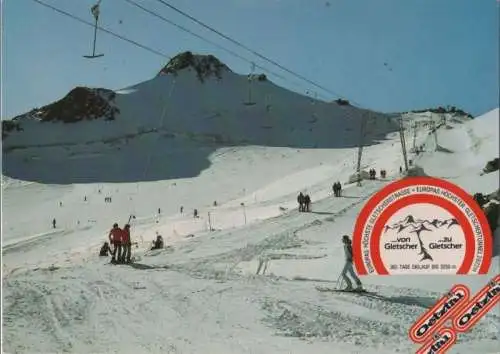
[2,48,500,354]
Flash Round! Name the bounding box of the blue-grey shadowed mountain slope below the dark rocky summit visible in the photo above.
[3,53,397,184]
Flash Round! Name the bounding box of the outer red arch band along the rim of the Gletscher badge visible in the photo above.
[352,176,493,275]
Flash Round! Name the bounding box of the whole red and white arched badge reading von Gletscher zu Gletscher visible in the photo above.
[352,177,492,275]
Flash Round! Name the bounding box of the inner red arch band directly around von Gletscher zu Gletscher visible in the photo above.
[370,194,476,275]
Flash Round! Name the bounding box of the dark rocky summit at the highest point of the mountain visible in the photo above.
[158,51,231,81]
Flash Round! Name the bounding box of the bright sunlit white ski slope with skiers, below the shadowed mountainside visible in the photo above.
[2,108,500,354]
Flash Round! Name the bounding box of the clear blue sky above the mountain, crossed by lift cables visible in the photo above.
[2,0,498,118]
